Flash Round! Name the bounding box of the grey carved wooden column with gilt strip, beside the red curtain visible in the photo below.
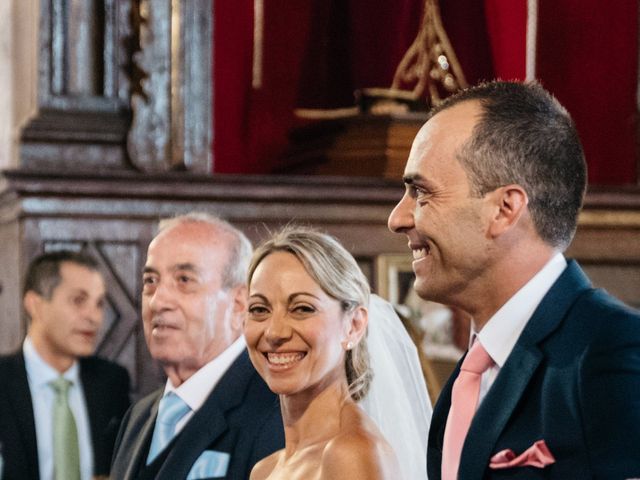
[128,0,213,173]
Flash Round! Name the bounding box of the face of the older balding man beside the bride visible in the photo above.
[142,223,237,370]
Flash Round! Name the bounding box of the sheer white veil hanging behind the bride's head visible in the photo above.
[360,295,432,480]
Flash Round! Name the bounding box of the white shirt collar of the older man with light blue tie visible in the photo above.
[164,335,246,412]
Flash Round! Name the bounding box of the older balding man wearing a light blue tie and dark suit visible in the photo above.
[112,213,284,480]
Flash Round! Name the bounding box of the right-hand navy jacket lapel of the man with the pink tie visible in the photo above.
[458,261,591,478]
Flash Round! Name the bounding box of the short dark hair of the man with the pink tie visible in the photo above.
[431,81,587,250]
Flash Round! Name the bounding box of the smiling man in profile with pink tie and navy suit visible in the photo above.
[389,82,640,480]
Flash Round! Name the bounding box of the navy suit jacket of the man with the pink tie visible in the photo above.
[427,261,640,480]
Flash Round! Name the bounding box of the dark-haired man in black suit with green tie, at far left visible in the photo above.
[0,251,129,480]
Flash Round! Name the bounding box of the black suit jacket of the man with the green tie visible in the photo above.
[0,351,130,480]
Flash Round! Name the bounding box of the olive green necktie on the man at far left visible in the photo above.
[49,376,80,480]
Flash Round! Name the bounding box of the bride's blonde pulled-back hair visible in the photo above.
[248,226,372,401]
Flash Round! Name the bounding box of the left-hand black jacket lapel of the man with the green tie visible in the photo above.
[7,351,38,478]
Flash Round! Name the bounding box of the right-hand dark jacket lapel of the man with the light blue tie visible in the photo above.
[157,350,254,479]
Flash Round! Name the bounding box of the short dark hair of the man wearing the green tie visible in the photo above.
[22,250,99,300]
